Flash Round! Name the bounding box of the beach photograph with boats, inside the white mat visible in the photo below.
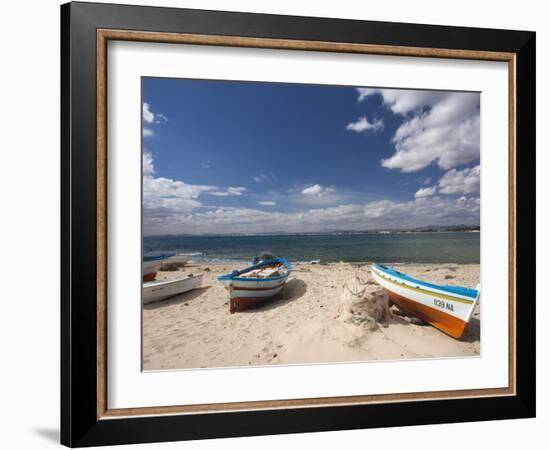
[140,77,482,371]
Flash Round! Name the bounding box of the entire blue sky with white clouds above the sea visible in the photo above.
[142,78,479,234]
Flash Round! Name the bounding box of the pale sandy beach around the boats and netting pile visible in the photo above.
[143,263,480,370]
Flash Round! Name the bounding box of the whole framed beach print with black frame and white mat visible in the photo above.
[61,3,535,446]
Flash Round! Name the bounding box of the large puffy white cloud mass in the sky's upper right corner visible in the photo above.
[358,88,480,172]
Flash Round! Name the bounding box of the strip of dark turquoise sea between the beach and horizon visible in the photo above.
[143,232,480,264]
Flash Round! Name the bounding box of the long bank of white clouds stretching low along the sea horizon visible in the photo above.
[143,151,479,235]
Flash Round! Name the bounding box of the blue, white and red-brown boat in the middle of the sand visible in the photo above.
[218,257,292,313]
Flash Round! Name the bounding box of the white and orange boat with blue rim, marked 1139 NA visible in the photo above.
[371,264,480,339]
